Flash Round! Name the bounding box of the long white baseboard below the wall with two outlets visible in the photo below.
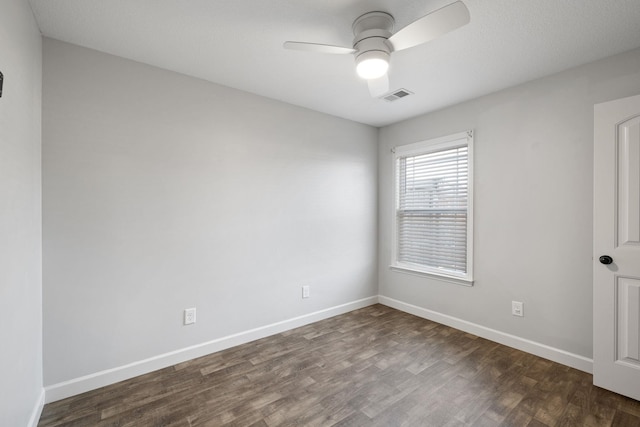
[47,296,378,402]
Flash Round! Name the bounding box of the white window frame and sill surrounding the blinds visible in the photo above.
[390,130,474,286]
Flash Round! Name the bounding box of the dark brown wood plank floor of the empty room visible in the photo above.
[38,305,640,427]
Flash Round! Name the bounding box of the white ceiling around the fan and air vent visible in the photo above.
[30,0,640,126]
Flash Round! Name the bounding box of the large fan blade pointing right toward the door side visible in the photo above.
[389,1,470,51]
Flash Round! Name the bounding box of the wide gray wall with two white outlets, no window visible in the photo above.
[43,39,378,385]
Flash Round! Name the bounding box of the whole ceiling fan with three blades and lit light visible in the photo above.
[284,1,470,97]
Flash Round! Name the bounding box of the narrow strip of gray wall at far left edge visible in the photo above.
[0,0,42,426]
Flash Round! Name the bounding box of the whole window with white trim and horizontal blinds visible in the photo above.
[391,131,473,285]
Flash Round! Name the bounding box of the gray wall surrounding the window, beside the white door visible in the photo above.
[379,50,640,357]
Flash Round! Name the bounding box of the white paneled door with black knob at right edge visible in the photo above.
[593,96,640,400]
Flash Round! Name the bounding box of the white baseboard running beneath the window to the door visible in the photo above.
[378,295,593,374]
